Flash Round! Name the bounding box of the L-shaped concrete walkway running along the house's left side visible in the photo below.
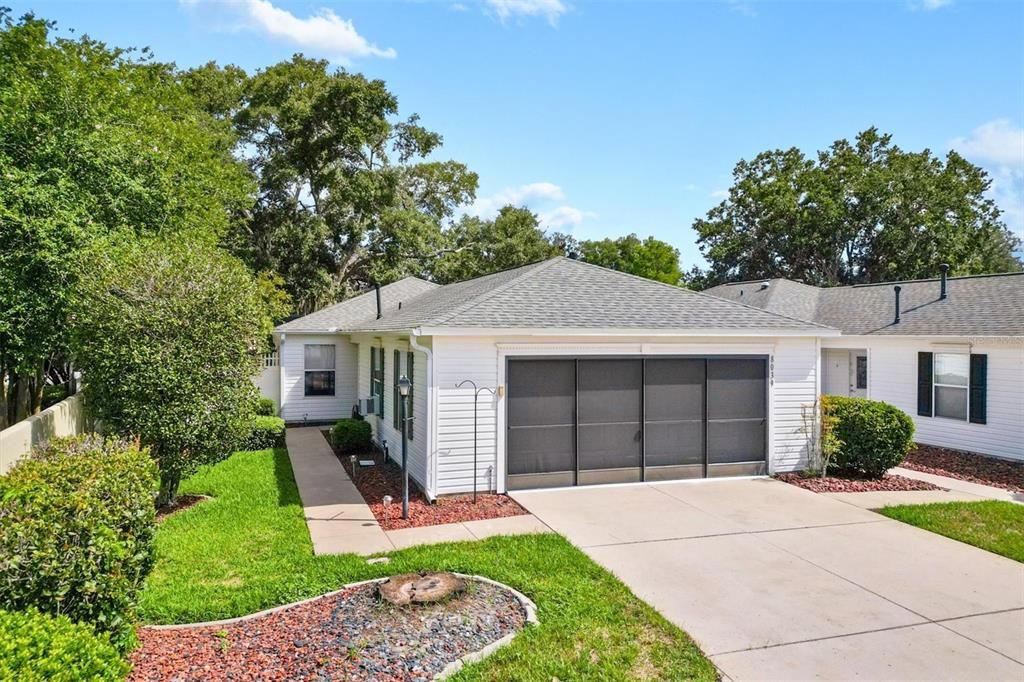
[285,427,551,556]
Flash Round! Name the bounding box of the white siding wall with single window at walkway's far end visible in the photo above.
[279,333,357,423]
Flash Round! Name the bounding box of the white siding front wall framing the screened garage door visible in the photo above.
[433,336,818,495]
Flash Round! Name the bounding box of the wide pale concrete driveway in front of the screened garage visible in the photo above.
[513,479,1024,681]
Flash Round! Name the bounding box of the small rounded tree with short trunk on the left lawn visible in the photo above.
[72,240,268,506]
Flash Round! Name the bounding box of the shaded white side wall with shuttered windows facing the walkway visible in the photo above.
[354,337,431,493]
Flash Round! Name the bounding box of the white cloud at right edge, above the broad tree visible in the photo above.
[949,119,1024,245]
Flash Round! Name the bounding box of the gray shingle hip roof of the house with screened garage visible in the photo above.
[279,257,835,335]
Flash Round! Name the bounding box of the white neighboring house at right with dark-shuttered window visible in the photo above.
[706,270,1024,459]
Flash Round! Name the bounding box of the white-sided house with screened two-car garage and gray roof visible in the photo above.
[271,258,840,498]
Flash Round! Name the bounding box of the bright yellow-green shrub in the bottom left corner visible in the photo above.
[0,609,128,682]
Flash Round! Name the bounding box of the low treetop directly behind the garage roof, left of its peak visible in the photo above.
[431,206,562,284]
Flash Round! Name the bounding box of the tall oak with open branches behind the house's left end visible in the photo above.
[224,55,477,312]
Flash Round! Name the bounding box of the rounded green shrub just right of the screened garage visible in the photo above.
[821,395,913,478]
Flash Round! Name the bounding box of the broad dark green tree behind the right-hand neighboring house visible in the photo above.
[693,128,1021,286]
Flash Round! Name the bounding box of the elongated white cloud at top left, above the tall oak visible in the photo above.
[182,0,397,63]
